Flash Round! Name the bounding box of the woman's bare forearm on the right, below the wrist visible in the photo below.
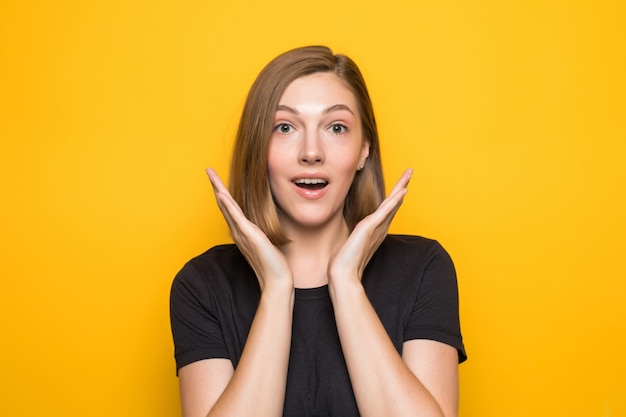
[330,280,443,417]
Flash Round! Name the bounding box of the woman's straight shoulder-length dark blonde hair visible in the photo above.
[230,46,385,245]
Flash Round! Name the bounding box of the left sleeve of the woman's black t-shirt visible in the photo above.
[170,262,228,372]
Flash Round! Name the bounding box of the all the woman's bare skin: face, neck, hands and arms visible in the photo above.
[179,73,458,417]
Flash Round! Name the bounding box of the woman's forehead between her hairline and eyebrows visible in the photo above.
[279,72,358,109]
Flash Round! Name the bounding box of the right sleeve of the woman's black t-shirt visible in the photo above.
[405,242,467,363]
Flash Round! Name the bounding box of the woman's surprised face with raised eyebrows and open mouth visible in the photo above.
[268,72,369,232]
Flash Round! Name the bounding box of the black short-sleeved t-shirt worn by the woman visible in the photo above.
[170,235,467,417]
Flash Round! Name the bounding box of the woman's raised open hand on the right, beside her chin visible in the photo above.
[328,169,413,282]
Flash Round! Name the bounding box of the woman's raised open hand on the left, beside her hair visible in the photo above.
[206,168,293,291]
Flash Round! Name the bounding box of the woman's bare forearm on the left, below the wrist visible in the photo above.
[209,288,294,417]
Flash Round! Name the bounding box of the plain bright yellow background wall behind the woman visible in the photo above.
[0,0,626,417]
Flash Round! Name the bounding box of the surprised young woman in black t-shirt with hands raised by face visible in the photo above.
[171,47,466,417]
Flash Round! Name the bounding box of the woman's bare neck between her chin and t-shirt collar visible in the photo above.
[281,218,349,288]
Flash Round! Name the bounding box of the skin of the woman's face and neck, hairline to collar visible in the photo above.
[268,73,369,288]
